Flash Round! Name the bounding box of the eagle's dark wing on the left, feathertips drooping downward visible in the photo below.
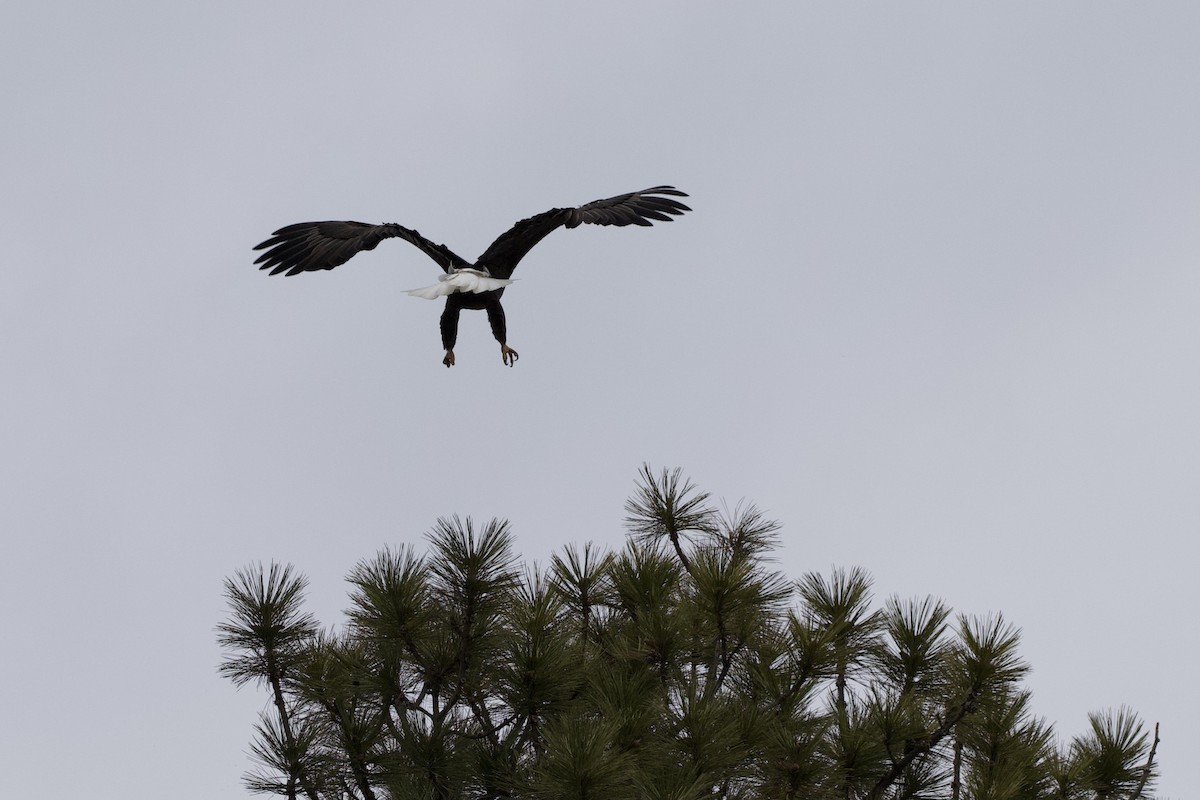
[254,222,470,275]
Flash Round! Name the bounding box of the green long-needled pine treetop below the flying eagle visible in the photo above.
[218,468,1158,800]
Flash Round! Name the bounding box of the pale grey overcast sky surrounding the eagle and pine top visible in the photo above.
[0,0,1200,800]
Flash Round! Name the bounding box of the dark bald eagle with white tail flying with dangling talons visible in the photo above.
[254,186,691,367]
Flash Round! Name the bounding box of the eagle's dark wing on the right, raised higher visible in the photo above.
[475,186,691,278]
